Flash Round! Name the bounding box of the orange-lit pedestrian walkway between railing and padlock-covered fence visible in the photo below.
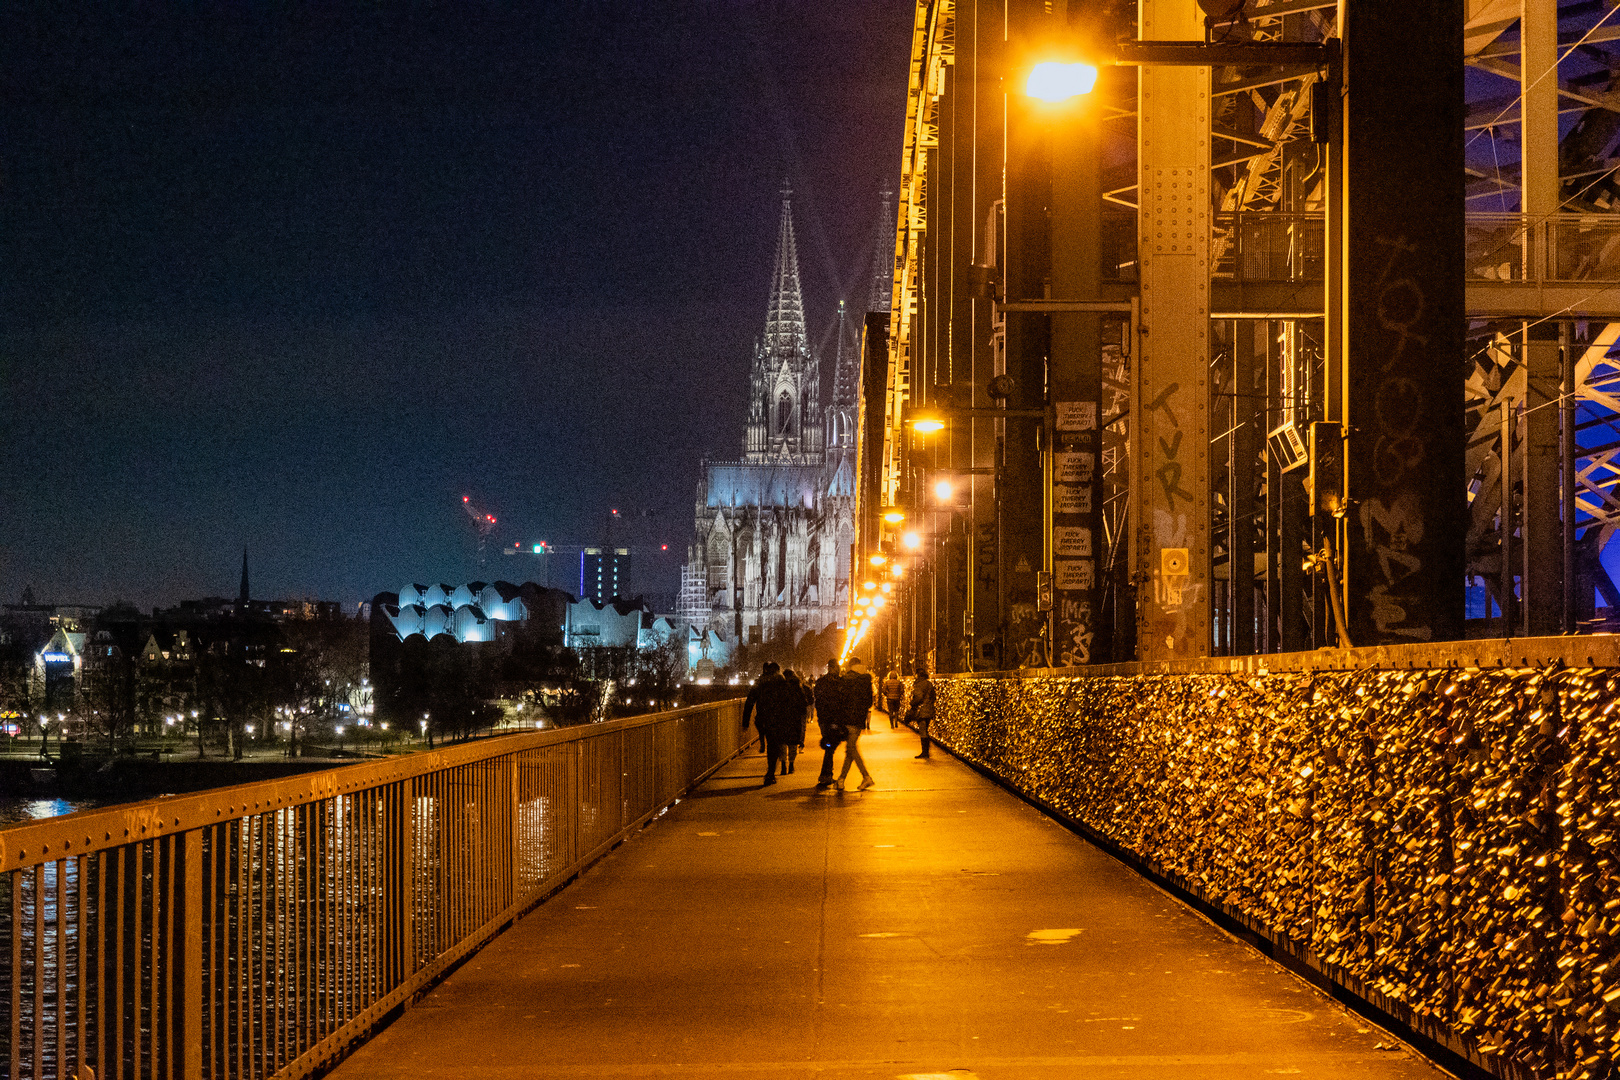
[335,714,1443,1080]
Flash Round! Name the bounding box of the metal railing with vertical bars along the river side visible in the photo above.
[0,701,747,1080]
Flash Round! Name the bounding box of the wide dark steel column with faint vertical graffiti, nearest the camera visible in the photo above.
[1333,0,1468,646]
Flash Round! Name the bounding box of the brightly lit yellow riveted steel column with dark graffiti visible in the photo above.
[1131,0,1210,661]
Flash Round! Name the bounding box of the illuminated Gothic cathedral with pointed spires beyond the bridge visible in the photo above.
[682,189,894,660]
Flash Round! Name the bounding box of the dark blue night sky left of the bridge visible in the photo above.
[0,0,910,607]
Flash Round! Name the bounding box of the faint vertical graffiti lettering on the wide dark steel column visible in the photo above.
[1359,238,1434,641]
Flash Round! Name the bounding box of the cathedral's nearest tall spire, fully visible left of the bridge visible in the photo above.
[744,186,826,465]
